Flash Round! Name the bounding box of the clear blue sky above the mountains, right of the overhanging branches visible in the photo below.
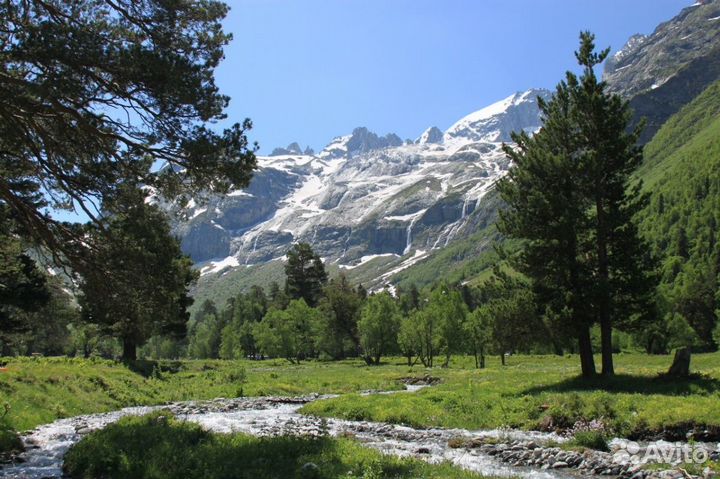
[217,0,693,153]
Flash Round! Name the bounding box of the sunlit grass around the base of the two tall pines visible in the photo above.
[303,353,720,437]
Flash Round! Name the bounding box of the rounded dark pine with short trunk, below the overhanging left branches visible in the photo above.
[80,187,197,360]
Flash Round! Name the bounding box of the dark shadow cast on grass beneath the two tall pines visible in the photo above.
[523,374,720,396]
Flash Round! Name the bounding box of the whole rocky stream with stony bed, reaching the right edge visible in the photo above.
[0,385,720,479]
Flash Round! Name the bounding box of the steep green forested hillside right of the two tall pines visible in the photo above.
[638,82,720,349]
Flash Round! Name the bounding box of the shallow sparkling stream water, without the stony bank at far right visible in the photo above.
[0,386,712,479]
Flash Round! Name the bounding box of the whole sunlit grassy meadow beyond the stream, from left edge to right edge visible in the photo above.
[0,353,720,462]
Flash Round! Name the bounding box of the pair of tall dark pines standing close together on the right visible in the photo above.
[499,32,655,376]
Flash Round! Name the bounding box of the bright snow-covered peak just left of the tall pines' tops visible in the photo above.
[444,89,550,143]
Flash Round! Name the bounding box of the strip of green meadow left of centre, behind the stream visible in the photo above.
[0,358,402,436]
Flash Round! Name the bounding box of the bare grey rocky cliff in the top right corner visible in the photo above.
[604,0,720,143]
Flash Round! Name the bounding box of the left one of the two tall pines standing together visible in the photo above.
[497,82,595,376]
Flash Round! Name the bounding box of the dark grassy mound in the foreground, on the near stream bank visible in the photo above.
[65,413,490,479]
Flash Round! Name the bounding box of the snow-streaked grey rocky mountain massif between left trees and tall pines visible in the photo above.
[167,90,549,280]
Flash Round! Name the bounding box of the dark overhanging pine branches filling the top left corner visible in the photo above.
[0,0,256,266]
